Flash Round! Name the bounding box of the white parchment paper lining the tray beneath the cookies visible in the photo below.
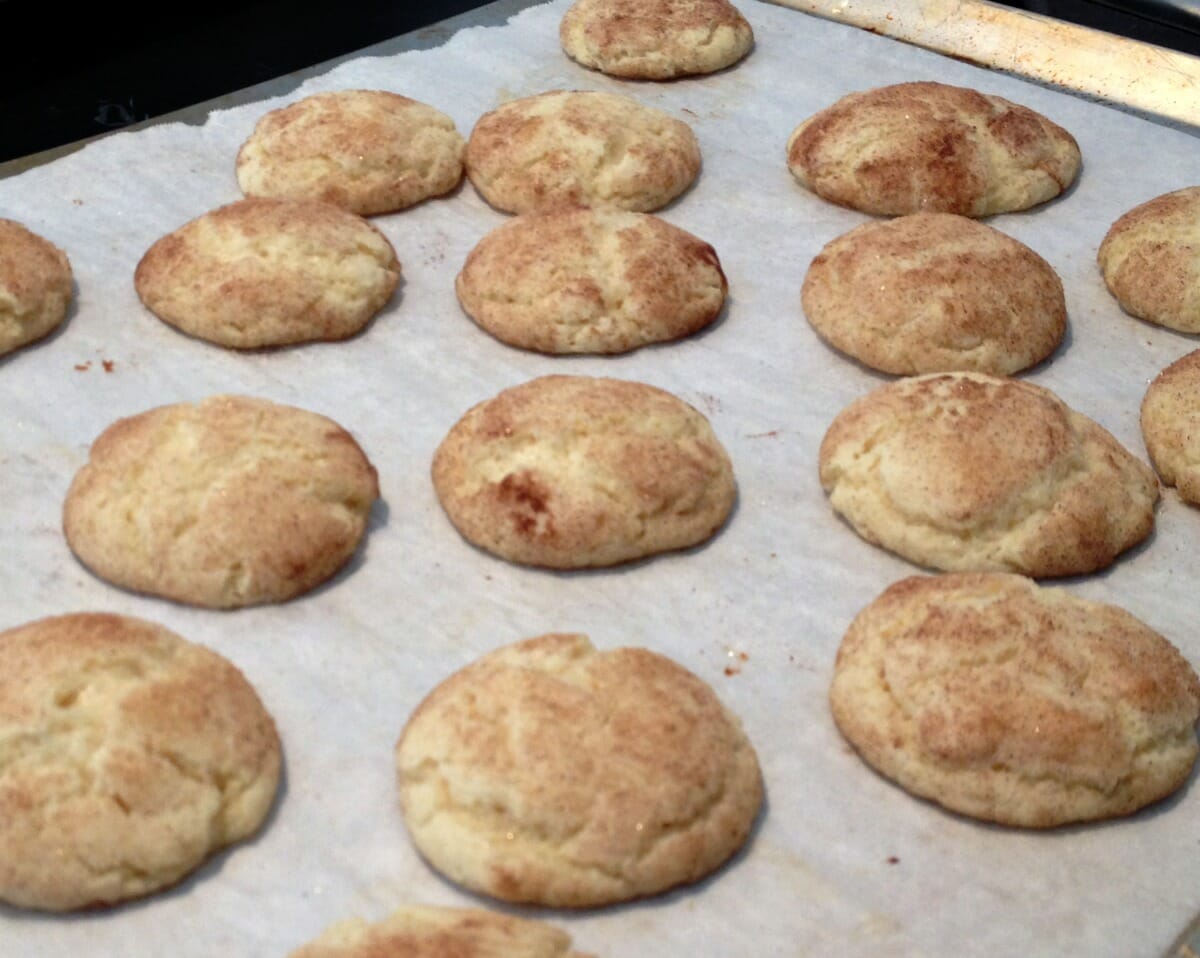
[0,0,1200,958]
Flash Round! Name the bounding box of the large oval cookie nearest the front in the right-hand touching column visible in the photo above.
[829,574,1200,828]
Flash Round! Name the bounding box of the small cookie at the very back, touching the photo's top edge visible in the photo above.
[558,0,754,80]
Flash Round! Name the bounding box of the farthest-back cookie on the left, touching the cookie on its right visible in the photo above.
[238,90,466,216]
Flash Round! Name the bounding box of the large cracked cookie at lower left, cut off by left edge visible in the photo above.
[0,613,281,912]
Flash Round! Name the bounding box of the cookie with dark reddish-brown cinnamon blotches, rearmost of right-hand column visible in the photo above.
[787,82,1080,216]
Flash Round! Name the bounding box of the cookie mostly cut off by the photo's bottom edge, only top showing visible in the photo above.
[289,905,590,958]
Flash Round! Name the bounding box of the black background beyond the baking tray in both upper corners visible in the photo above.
[0,0,1200,162]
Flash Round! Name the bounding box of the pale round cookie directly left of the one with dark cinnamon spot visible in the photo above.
[62,396,379,609]
